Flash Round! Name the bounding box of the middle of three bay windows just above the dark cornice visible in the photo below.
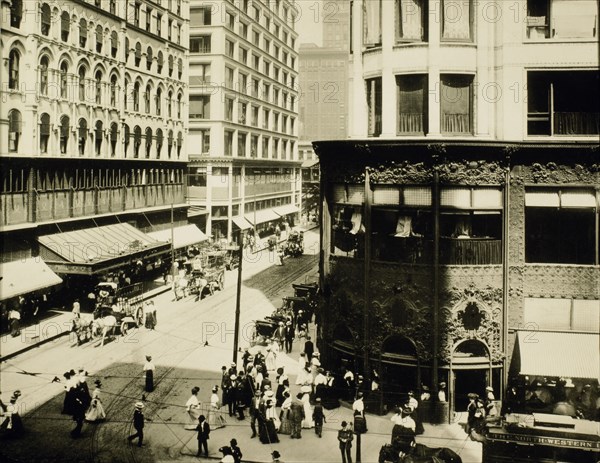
[396,74,428,135]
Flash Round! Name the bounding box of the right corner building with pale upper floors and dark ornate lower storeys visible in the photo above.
[314,0,600,418]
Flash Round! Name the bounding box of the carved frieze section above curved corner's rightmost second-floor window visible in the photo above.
[439,159,506,185]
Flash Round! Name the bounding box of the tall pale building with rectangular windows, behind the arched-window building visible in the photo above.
[187,0,301,245]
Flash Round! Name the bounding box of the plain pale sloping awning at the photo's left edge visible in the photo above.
[0,257,62,301]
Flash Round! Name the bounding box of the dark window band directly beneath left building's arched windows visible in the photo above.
[0,168,183,193]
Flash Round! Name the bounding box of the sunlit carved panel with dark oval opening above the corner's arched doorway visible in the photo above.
[439,284,504,362]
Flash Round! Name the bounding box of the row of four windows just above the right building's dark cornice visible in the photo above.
[365,71,600,136]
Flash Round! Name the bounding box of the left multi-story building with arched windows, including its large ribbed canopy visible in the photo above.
[0,0,188,300]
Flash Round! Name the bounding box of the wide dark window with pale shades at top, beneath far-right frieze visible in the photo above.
[525,189,597,265]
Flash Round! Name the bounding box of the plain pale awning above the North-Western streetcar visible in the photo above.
[511,331,600,379]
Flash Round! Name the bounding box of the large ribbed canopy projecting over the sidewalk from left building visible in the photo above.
[38,223,171,275]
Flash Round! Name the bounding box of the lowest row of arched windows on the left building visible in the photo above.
[8,109,183,159]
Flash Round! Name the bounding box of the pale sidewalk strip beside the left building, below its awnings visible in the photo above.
[0,285,171,362]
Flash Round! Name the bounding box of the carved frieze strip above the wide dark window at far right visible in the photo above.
[523,161,600,185]
